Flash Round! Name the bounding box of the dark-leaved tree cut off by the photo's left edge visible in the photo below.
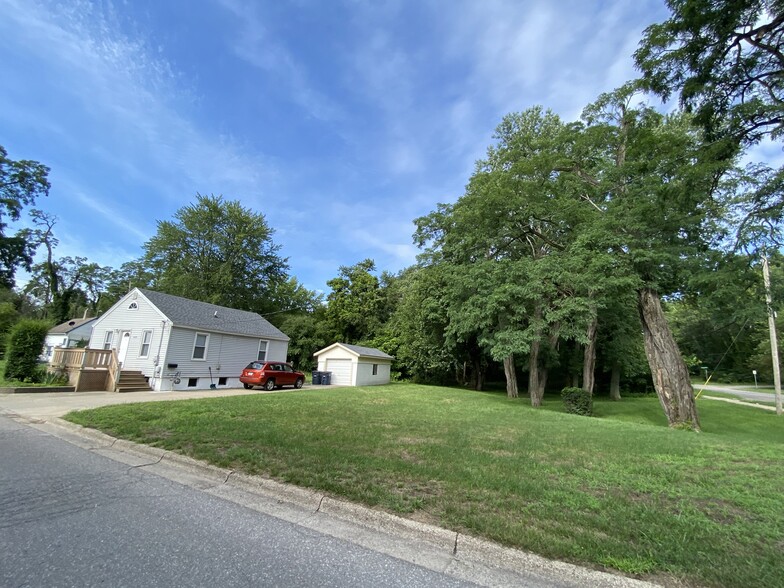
[0,145,51,287]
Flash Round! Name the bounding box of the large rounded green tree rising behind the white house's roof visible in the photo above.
[144,194,288,314]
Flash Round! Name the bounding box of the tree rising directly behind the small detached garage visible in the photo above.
[326,259,382,343]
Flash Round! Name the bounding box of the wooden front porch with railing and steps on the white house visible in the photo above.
[49,347,150,392]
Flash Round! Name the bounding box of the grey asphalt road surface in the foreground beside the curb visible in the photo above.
[0,416,475,588]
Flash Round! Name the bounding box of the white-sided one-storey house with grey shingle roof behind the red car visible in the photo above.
[89,288,289,391]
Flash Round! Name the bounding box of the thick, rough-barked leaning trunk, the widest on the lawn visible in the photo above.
[637,288,700,431]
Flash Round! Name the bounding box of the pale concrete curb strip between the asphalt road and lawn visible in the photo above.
[35,415,659,588]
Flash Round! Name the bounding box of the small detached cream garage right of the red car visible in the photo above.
[313,343,394,386]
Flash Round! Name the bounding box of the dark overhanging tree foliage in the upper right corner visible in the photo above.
[634,0,784,143]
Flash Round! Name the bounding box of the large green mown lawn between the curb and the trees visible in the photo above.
[66,385,784,586]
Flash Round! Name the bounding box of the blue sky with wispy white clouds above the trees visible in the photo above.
[0,0,668,291]
